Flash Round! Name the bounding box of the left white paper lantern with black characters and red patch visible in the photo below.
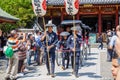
[32,0,47,17]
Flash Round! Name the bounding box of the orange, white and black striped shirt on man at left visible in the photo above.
[7,38,20,53]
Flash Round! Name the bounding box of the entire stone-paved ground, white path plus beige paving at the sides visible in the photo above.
[0,43,113,80]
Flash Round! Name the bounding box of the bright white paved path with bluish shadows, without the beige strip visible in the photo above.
[18,48,101,80]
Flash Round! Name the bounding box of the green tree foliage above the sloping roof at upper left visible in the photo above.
[0,0,35,31]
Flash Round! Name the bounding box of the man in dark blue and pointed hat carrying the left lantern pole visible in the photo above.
[41,21,58,77]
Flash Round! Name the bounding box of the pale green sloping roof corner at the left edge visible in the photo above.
[0,8,19,22]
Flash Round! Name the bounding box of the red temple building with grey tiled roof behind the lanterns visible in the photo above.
[39,0,120,33]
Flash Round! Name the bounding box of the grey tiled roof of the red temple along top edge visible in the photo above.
[47,0,120,5]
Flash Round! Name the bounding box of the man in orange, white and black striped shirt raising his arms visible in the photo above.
[5,30,25,80]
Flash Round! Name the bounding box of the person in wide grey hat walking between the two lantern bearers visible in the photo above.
[58,32,69,70]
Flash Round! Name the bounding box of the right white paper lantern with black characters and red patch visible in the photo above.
[64,0,79,15]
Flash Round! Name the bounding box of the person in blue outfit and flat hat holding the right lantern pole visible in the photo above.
[68,27,82,77]
